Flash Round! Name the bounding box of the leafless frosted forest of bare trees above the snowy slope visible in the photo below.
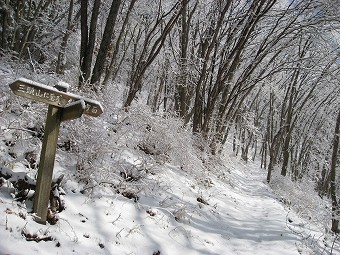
[0,0,340,232]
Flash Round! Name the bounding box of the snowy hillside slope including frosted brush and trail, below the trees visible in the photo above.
[0,65,340,255]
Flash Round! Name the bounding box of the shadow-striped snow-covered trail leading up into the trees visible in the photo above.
[191,159,300,255]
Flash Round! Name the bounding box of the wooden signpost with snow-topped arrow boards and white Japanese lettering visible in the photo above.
[9,78,103,224]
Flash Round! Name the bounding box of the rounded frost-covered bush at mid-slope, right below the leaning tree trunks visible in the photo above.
[120,106,202,168]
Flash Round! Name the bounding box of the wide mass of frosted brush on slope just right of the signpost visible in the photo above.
[61,105,203,193]
